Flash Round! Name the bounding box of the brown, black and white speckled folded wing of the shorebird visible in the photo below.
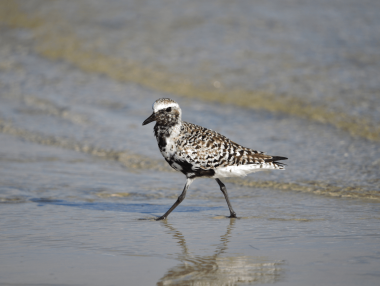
[176,122,281,170]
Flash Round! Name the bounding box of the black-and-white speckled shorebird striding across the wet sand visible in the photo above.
[142,98,288,220]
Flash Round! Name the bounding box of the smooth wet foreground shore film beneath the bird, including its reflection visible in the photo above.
[0,135,380,285]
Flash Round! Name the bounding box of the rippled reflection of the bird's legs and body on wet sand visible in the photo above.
[157,218,284,286]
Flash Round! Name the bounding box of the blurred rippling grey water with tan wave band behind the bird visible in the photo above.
[0,0,380,198]
